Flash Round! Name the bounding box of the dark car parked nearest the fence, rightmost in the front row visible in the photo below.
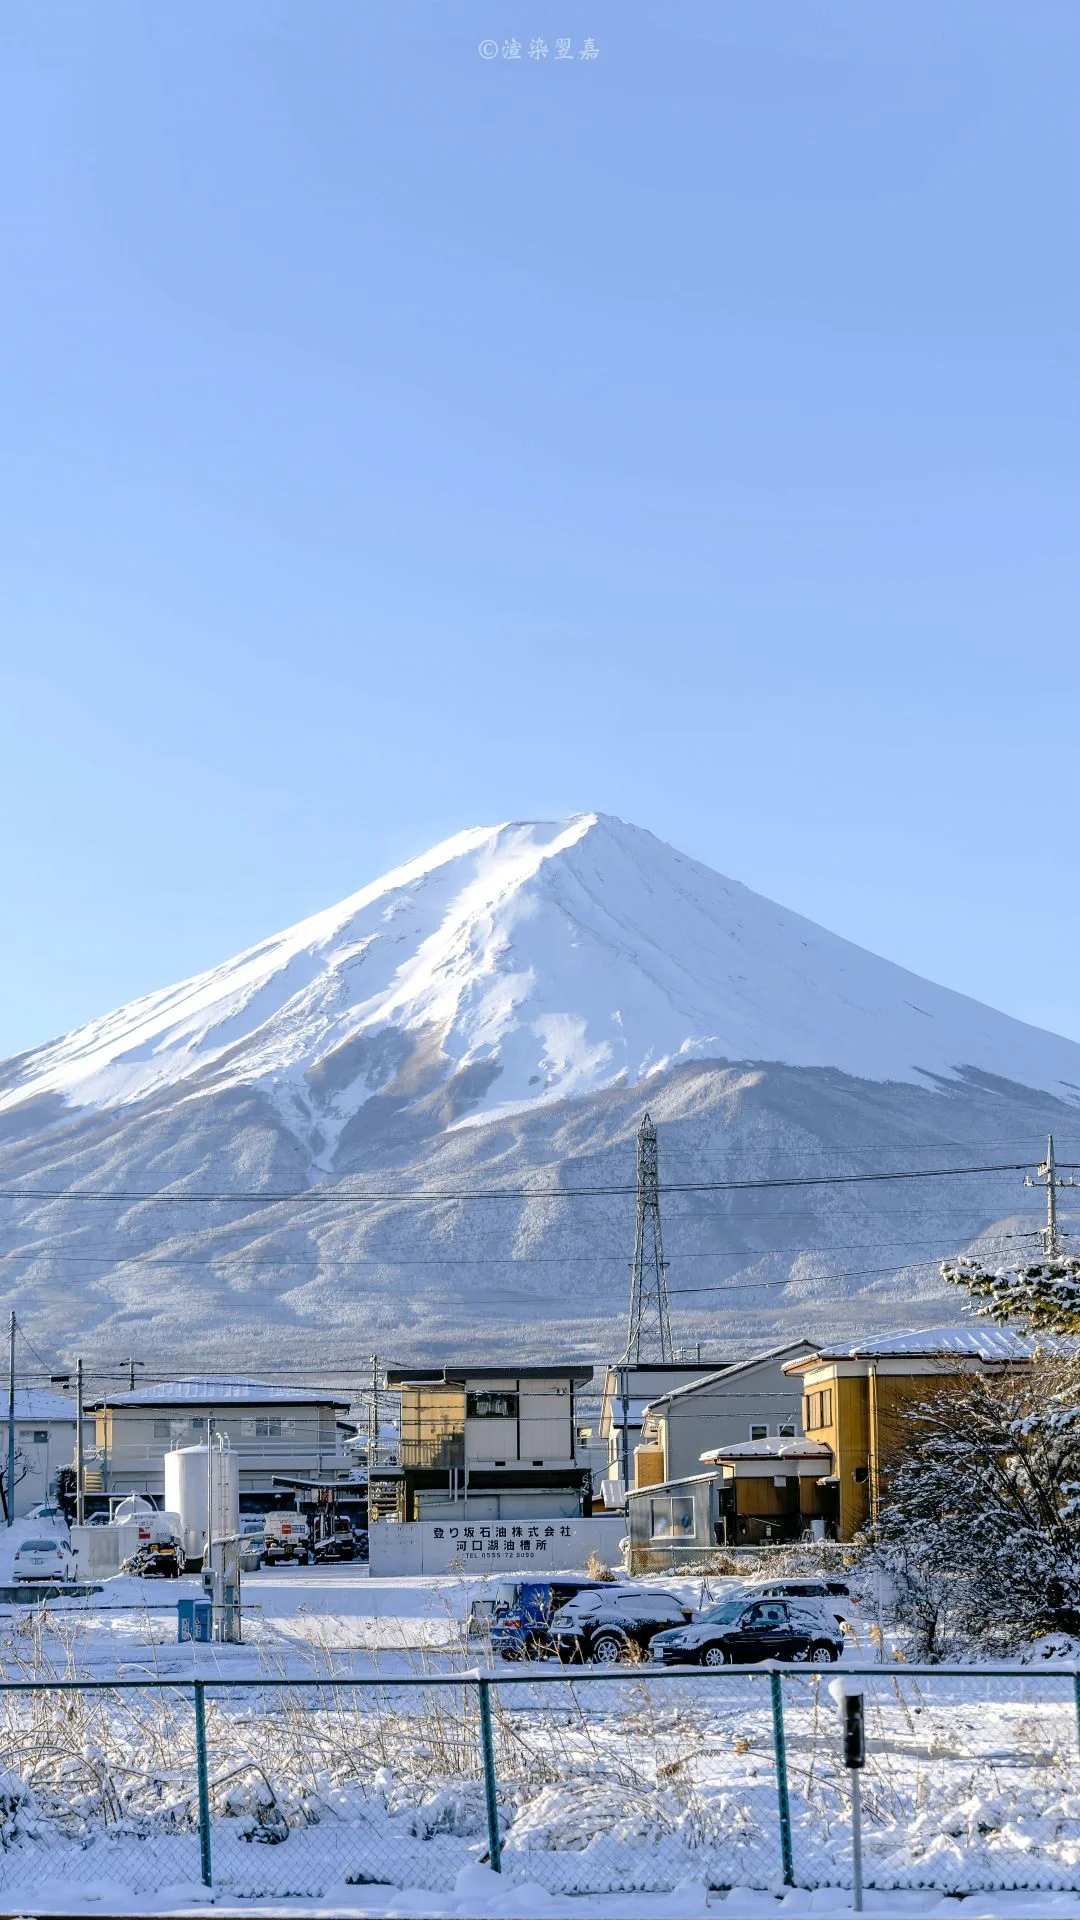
[650,1596,844,1667]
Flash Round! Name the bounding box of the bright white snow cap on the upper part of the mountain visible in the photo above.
[0,814,1080,1169]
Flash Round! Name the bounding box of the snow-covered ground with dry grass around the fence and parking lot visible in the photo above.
[0,1567,1080,1920]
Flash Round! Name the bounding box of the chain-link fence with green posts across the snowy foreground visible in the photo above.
[0,1665,1080,1907]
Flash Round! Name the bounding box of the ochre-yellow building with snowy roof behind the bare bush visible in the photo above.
[784,1323,1032,1540]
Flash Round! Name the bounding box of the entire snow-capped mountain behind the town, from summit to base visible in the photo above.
[0,814,1080,1367]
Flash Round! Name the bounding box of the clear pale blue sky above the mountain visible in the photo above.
[0,0,1080,1052]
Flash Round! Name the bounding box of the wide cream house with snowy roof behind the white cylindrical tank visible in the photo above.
[86,1375,354,1507]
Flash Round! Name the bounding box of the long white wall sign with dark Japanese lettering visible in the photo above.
[367,1513,626,1576]
